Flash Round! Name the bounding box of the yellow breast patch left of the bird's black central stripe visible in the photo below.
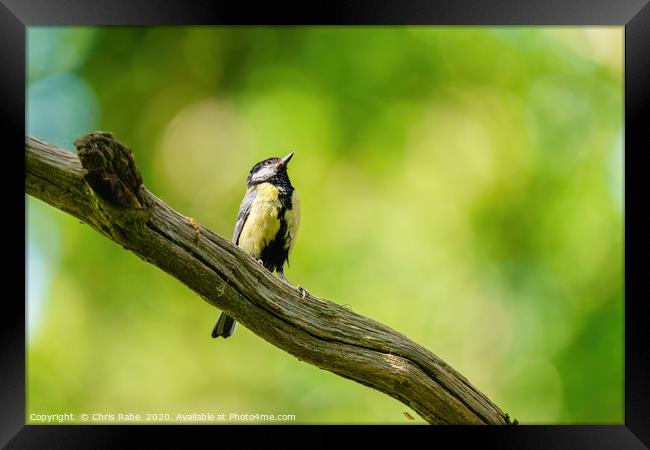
[239,183,281,258]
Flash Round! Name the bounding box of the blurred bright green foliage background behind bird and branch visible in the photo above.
[27,27,623,423]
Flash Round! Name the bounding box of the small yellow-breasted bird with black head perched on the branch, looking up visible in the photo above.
[212,152,306,339]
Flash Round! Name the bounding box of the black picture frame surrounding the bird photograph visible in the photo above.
[0,0,650,449]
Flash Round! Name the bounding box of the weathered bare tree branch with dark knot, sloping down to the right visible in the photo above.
[25,133,510,424]
